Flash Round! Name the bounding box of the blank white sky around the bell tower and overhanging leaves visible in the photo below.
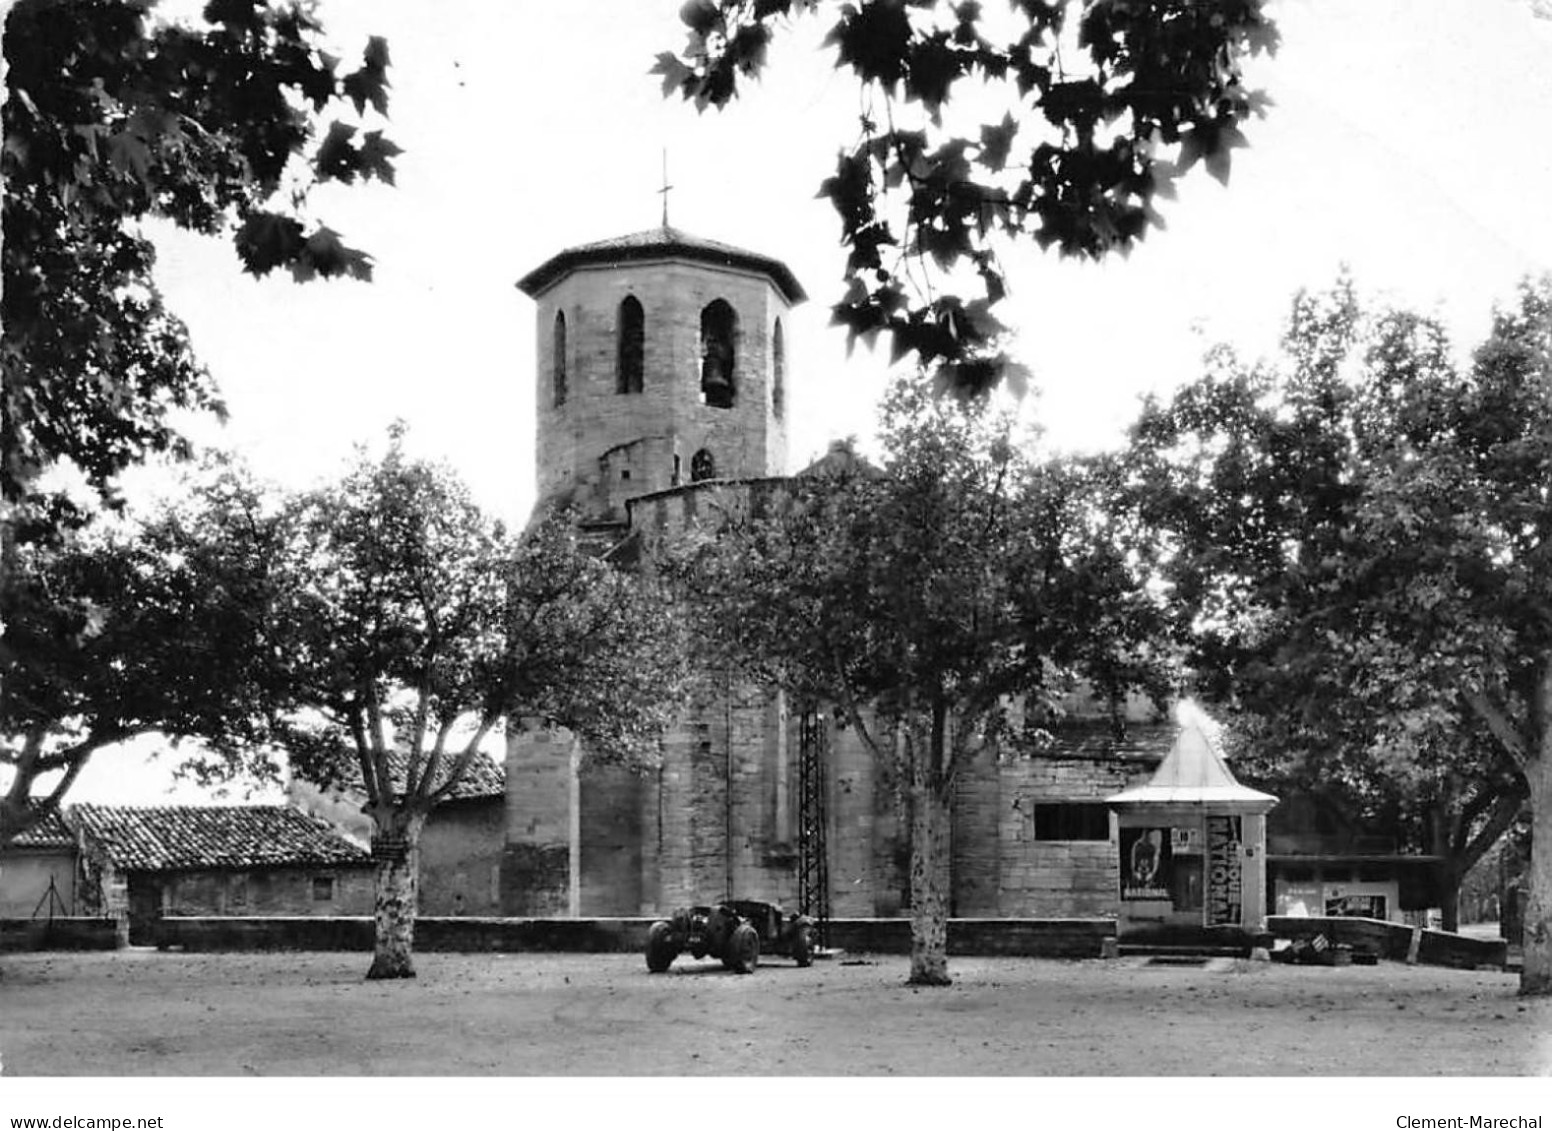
[73,0,1552,802]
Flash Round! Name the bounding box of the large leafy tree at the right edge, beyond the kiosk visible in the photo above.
[1133,284,1552,993]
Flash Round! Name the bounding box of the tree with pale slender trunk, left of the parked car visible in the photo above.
[254,430,681,977]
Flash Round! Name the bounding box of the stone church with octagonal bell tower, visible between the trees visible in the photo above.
[500,222,1175,918]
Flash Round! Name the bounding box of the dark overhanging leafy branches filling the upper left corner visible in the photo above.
[0,0,399,504]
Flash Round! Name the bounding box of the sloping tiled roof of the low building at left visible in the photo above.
[68,805,369,872]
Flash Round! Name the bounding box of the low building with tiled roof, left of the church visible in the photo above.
[67,805,376,945]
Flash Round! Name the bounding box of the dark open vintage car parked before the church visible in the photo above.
[647,900,818,974]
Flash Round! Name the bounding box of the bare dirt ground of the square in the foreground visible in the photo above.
[0,949,1552,1077]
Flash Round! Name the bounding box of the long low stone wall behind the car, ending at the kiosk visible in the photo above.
[158,917,1116,959]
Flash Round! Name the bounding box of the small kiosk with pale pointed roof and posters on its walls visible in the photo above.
[1107,704,1277,946]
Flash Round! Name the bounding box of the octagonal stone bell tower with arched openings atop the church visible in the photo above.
[517,225,807,523]
